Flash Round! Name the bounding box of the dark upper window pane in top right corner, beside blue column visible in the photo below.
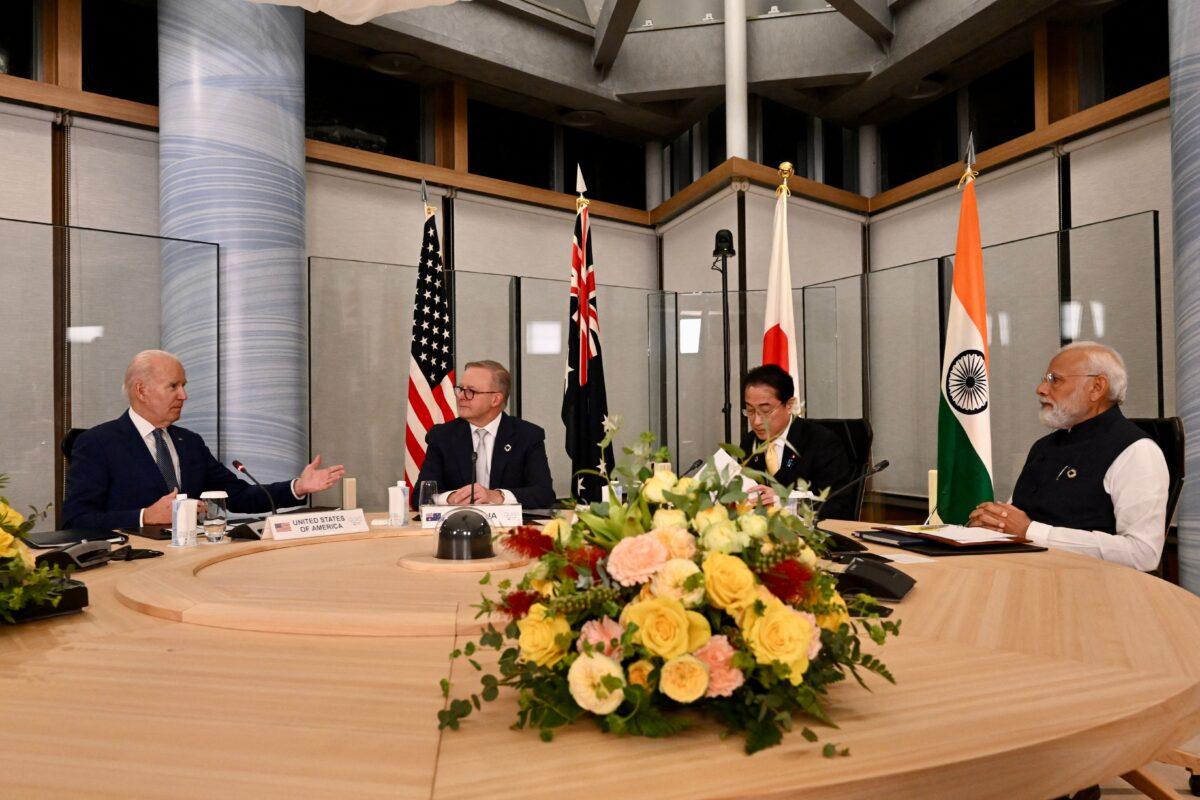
[1100,0,1170,100]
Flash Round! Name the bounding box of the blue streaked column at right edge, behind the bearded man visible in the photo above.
[1170,0,1200,594]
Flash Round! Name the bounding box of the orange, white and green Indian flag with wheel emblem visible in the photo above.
[937,172,992,524]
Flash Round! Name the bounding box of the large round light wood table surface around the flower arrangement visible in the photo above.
[7,515,1200,800]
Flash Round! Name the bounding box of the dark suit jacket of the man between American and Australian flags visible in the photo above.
[413,414,554,509]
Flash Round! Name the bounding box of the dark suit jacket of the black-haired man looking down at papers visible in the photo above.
[742,417,856,519]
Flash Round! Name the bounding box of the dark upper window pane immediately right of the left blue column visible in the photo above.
[305,55,421,161]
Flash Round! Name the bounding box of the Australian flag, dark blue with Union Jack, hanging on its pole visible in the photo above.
[563,197,613,501]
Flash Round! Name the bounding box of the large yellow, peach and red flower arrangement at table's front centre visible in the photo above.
[438,431,899,757]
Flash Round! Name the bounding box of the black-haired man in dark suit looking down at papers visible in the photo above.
[742,363,854,519]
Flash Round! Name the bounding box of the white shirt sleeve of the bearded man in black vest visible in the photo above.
[1025,439,1170,571]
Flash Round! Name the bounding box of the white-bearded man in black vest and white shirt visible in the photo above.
[970,342,1170,570]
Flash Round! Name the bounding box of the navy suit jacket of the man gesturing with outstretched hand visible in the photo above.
[62,411,300,529]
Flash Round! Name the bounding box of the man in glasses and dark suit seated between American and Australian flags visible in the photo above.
[413,361,554,509]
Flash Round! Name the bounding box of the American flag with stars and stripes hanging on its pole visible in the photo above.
[404,189,455,487]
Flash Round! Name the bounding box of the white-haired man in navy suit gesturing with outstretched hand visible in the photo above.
[62,350,344,529]
